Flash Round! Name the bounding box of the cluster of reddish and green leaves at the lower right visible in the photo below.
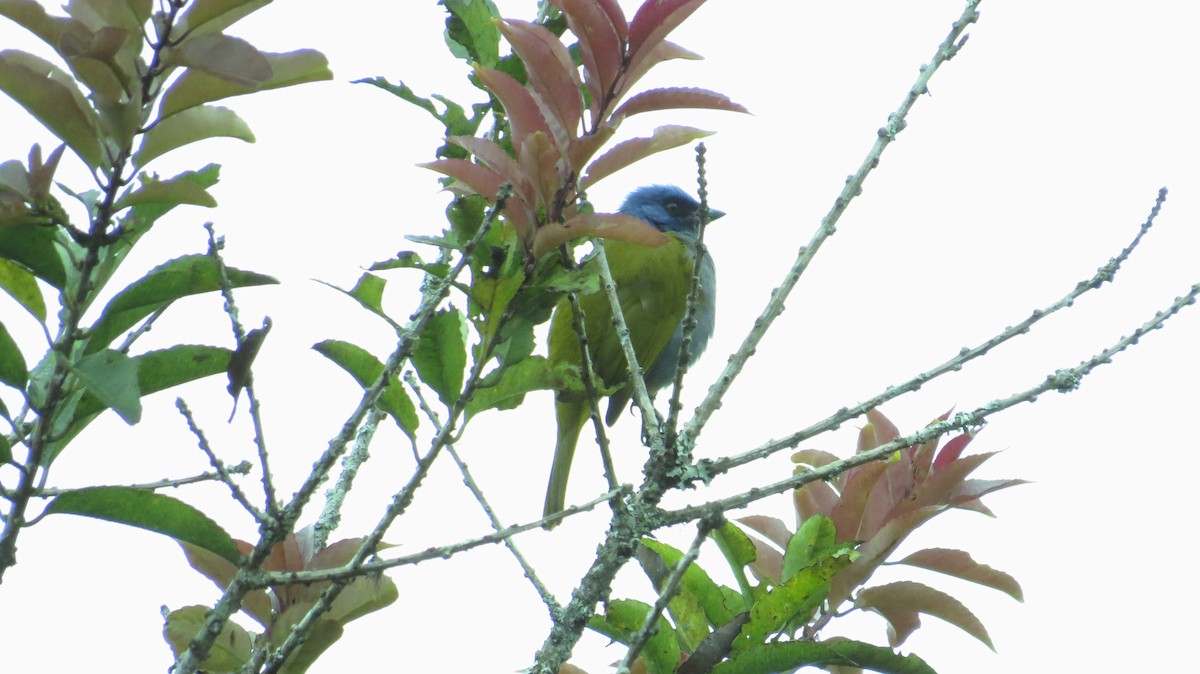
[580,410,1022,674]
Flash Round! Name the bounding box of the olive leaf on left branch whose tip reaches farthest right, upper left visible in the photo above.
[158,49,334,119]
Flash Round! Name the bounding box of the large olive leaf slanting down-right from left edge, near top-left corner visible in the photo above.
[0,49,103,169]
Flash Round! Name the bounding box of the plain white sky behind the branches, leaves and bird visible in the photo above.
[0,0,1200,673]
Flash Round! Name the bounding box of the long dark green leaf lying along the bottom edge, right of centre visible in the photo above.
[712,640,936,674]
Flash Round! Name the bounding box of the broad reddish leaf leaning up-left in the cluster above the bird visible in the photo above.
[499,19,583,141]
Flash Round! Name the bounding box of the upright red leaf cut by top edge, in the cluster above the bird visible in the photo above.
[554,0,628,115]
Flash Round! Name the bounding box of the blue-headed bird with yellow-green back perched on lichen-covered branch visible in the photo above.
[544,185,725,517]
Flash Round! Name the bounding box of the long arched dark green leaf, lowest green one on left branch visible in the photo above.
[46,487,241,564]
